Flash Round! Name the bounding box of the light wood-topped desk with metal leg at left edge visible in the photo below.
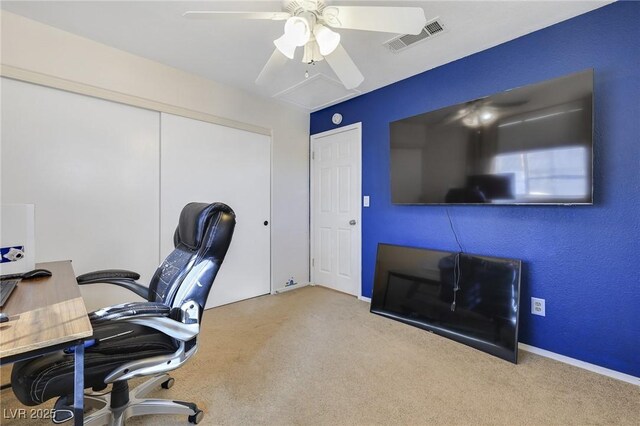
[0,261,93,425]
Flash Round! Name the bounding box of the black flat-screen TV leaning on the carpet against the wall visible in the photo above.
[371,244,521,363]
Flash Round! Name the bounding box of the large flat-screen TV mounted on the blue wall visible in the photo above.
[390,69,593,204]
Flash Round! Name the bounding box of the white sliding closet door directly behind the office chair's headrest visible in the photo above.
[160,113,271,308]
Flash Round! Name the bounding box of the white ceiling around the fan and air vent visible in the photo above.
[2,0,612,111]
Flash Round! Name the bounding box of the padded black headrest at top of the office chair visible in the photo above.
[173,203,234,250]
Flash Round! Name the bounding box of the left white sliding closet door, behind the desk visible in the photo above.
[2,78,160,309]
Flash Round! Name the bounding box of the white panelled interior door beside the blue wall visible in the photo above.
[311,123,362,296]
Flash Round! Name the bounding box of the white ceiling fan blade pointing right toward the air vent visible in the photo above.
[322,6,427,34]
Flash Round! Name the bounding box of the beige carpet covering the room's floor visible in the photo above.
[2,287,640,426]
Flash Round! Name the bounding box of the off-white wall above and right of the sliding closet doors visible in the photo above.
[1,11,309,289]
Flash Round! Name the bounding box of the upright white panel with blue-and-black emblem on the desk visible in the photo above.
[0,204,36,275]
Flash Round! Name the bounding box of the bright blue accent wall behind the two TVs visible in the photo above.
[311,2,640,377]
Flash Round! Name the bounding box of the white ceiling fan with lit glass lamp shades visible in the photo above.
[183,0,426,89]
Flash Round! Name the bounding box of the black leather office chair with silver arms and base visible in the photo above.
[11,203,235,425]
